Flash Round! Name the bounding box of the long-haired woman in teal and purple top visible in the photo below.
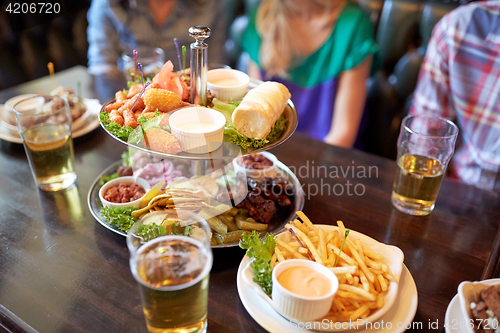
[242,0,378,147]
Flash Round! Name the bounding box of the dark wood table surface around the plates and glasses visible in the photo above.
[0,67,500,333]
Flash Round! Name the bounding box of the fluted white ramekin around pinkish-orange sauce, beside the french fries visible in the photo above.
[272,259,339,321]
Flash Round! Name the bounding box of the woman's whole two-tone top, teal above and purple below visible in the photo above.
[242,2,378,140]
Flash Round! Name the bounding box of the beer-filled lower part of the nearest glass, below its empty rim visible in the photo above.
[127,210,213,333]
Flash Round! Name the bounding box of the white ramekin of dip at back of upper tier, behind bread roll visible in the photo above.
[207,68,250,102]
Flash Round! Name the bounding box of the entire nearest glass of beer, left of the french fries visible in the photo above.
[127,210,213,333]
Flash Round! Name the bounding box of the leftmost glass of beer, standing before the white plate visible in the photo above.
[13,95,76,191]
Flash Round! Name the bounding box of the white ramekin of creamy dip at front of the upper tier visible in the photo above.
[168,107,226,154]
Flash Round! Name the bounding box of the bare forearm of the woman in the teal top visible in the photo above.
[323,56,372,148]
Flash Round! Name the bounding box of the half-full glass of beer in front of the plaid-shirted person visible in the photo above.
[392,115,458,216]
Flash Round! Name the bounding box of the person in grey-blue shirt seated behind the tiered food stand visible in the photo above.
[87,0,227,78]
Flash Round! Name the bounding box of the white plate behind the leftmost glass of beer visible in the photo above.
[0,100,101,143]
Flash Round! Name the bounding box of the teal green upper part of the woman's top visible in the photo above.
[242,2,378,87]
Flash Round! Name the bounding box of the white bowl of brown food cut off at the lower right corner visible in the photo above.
[458,279,500,333]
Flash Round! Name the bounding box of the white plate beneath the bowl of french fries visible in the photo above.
[236,231,418,333]
